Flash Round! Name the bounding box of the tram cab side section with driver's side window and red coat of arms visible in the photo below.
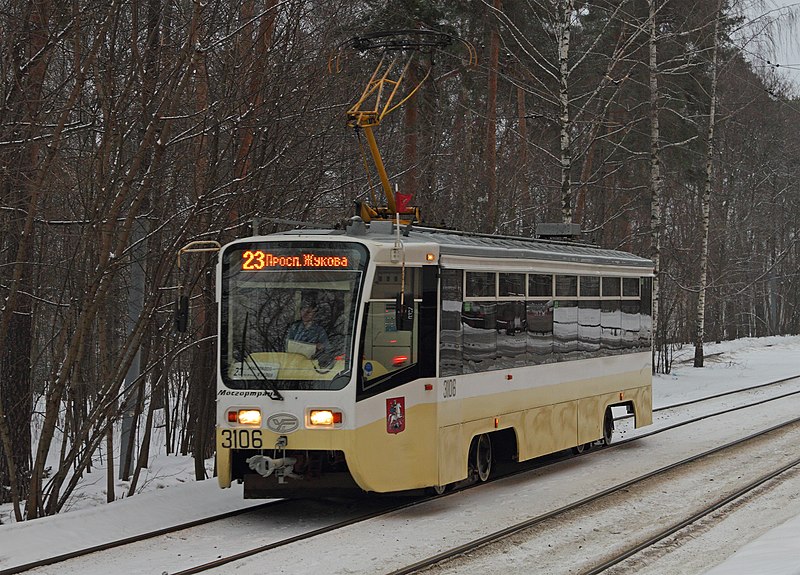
[351,266,437,492]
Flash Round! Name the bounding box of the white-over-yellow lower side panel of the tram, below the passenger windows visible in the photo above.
[438,354,652,485]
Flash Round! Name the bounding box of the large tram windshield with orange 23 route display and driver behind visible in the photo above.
[220,242,367,390]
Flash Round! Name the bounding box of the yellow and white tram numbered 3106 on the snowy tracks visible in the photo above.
[216,221,652,498]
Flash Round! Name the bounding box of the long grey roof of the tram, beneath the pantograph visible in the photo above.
[272,222,653,271]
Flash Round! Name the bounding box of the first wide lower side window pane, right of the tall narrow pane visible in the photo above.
[461,302,497,373]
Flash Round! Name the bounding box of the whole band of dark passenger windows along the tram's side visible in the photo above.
[439,270,652,376]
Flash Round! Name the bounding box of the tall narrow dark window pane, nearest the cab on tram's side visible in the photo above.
[439,269,464,377]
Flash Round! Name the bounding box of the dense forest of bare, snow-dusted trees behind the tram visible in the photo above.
[0,0,800,520]
